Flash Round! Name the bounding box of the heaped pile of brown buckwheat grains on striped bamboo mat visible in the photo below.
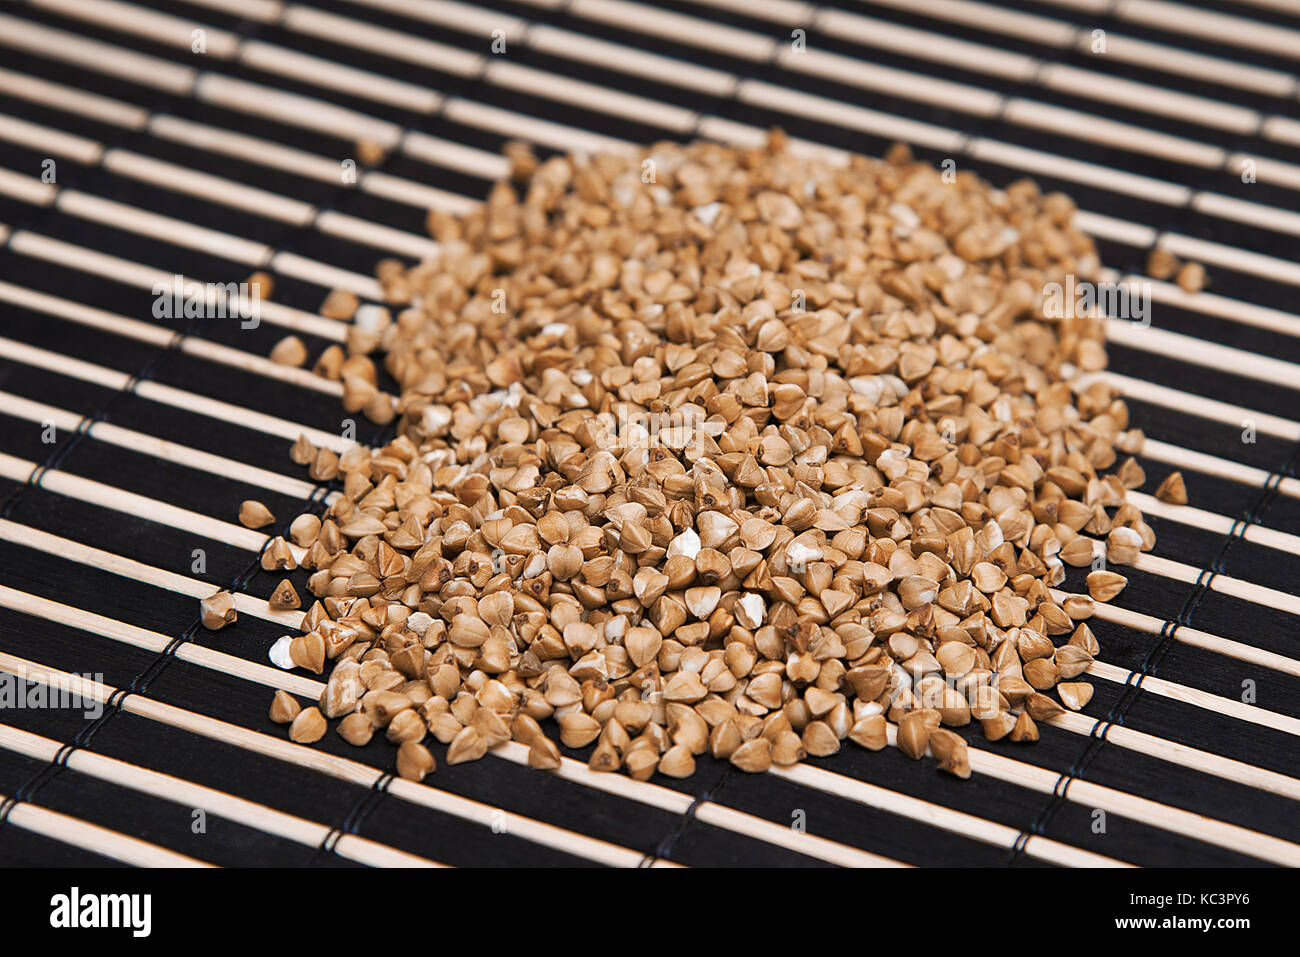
[228,131,1154,779]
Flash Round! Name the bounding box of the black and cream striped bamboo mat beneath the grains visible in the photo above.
[0,0,1300,866]
